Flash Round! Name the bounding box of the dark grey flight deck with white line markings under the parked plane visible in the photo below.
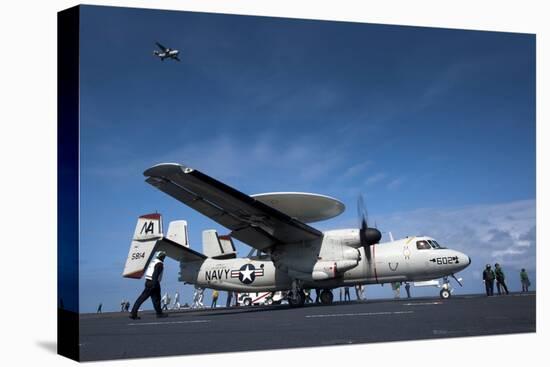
[80,293,536,361]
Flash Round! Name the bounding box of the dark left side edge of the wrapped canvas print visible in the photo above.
[57,6,80,361]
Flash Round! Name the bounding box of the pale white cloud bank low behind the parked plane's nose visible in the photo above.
[379,200,536,274]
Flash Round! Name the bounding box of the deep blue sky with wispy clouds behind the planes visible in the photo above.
[76,6,536,312]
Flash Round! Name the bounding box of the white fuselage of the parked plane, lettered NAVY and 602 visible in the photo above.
[180,234,470,292]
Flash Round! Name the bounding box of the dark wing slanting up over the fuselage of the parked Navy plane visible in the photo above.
[143,163,322,250]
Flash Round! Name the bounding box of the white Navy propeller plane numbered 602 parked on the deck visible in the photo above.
[123,163,471,306]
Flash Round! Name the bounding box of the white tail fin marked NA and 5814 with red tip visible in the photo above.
[122,213,163,279]
